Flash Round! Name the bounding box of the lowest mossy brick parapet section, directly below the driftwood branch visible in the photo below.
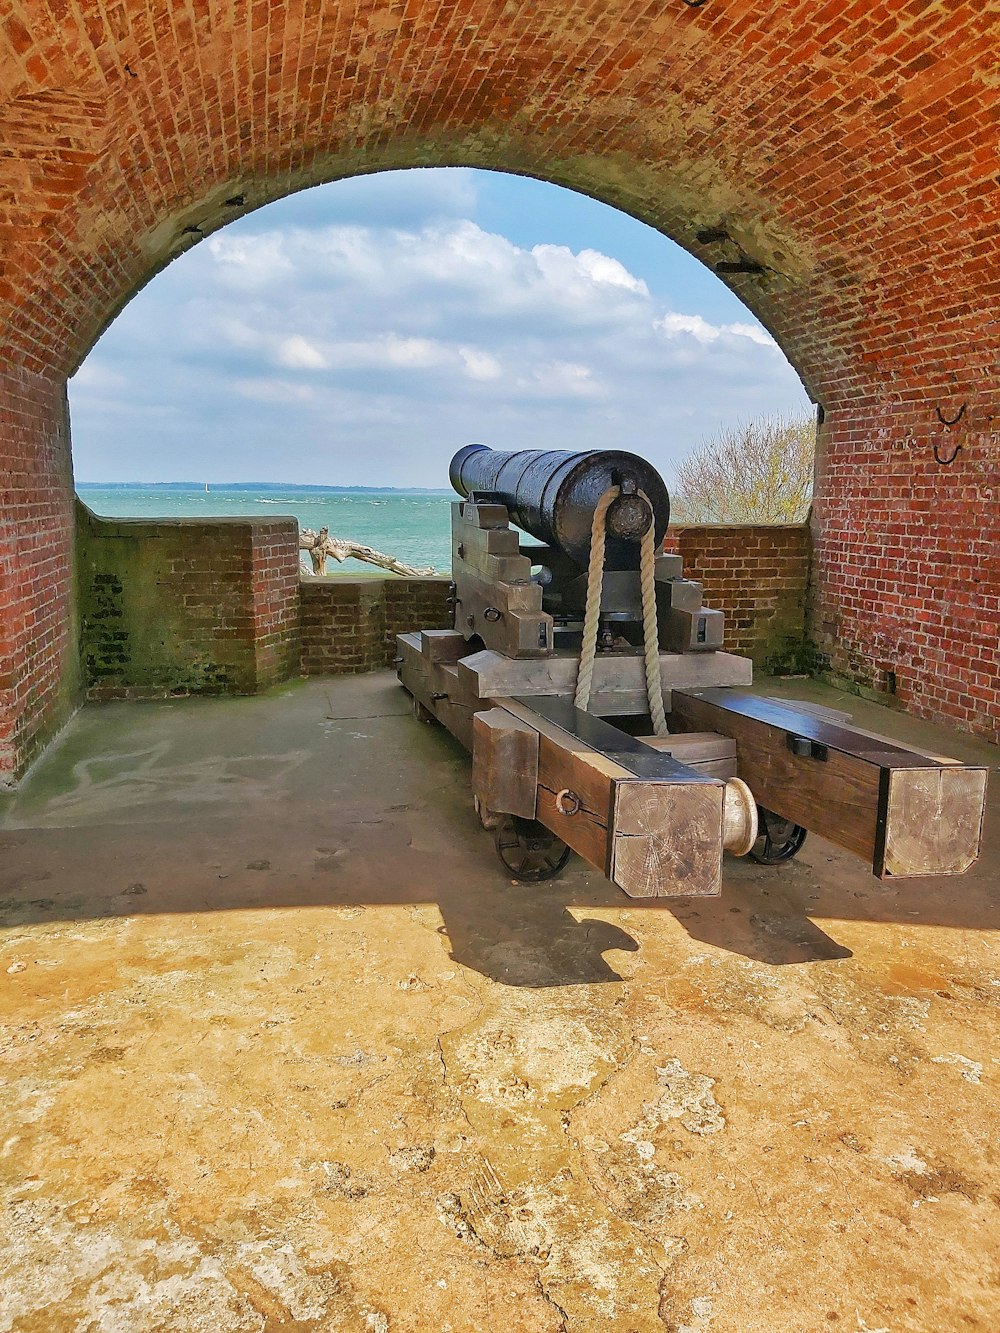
[301,575,452,676]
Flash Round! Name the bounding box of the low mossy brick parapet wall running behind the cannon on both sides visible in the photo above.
[77,504,809,700]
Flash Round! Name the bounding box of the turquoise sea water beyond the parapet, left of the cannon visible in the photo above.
[77,485,457,573]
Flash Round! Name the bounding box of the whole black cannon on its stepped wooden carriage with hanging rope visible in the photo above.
[396,444,987,898]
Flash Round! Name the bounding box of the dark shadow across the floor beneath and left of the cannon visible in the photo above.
[0,673,1000,986]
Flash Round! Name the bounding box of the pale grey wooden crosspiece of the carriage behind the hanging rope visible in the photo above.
[459,649,753,717]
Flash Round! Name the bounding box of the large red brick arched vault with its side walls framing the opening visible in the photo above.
[0,0,1000,772]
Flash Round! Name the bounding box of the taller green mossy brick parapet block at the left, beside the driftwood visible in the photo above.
[77,505,299,700]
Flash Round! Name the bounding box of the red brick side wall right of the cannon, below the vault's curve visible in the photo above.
[812,405,1000,740]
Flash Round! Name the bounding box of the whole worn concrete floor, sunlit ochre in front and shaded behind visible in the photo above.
[0,674,1000,1333]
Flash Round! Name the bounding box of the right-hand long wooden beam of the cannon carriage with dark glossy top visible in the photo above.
[671,689,985,878]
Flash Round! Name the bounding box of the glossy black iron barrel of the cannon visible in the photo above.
[449,444,671,568]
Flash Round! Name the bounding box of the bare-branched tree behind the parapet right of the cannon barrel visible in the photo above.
[672,416,816,523]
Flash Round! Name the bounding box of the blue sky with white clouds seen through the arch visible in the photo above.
[69,168,811,488]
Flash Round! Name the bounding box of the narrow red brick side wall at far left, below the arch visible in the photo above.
[0,369,79,786]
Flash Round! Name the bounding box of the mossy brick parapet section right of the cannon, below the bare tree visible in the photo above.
[664,524,815,672]
